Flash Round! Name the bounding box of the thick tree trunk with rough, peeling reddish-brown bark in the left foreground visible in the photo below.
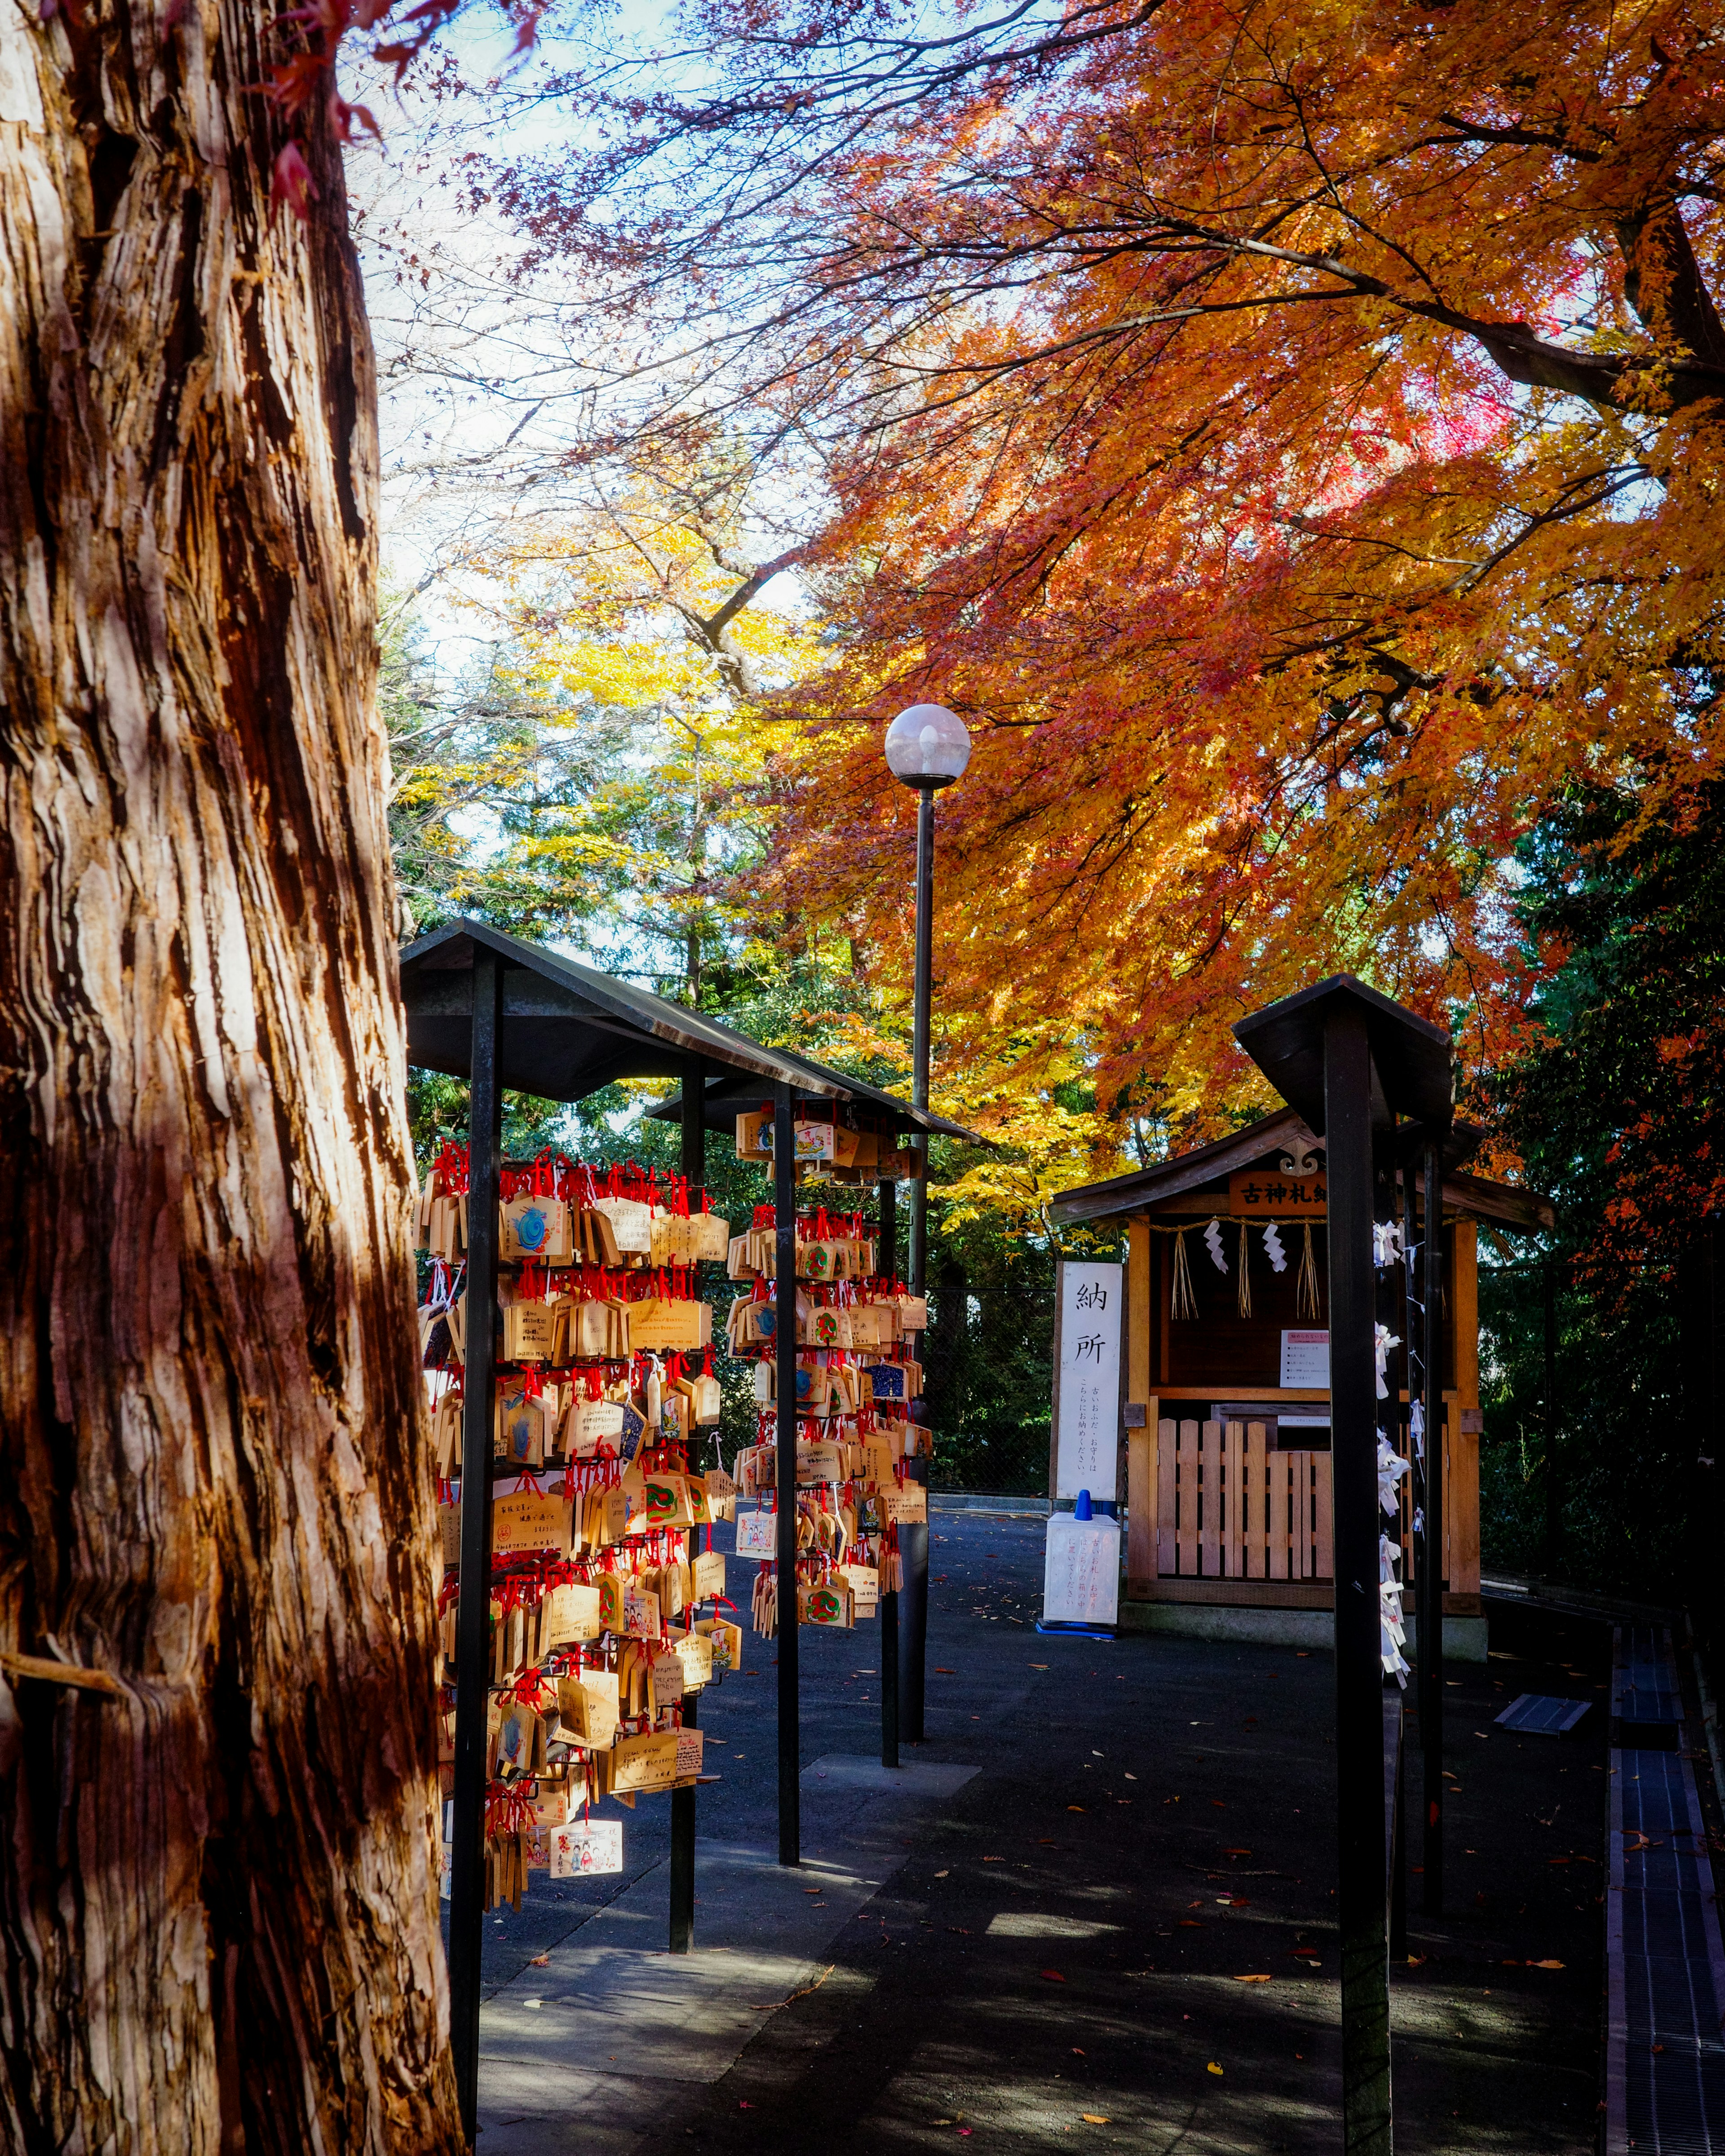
[0,0,459,2156]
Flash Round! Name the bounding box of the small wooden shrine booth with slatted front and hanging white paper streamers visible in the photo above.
[1048,1108,1552,1660]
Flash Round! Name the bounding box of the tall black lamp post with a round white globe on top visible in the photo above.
[880,703,970,1744]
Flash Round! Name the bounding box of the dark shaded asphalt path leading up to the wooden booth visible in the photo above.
[451,1514,1609,2156]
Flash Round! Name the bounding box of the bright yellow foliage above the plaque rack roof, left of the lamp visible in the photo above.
[394,459,817,974]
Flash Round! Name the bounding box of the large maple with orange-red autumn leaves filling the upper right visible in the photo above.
[474,0,1725,1198]
